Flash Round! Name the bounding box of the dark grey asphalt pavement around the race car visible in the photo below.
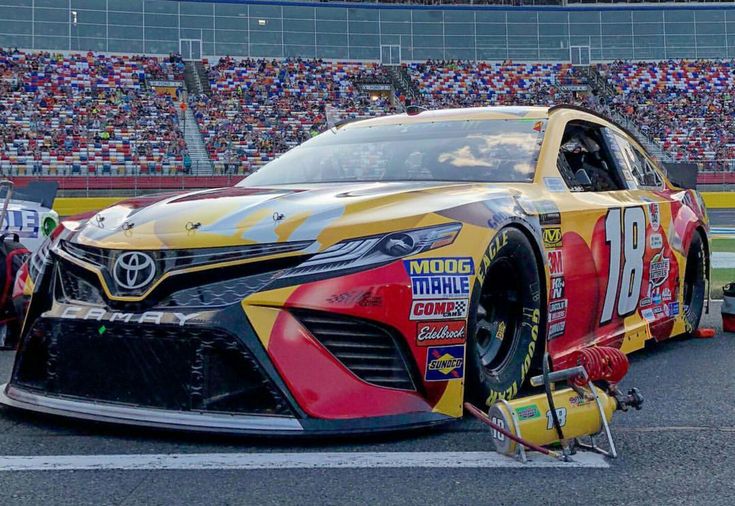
[0,304,735,505]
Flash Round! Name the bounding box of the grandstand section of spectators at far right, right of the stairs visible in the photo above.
[599,60,735,170]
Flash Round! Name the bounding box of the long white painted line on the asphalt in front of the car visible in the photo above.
[0,452,610,471]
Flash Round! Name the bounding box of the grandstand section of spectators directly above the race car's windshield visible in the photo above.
[189,57,395,173]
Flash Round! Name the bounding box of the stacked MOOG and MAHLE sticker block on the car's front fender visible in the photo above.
[404,257,475,299]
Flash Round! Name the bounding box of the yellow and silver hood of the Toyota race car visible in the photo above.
[68,182,519,250]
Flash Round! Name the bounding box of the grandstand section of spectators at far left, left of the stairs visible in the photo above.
[0,49,188,175]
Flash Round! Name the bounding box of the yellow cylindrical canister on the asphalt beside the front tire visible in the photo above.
[488,388,617,455]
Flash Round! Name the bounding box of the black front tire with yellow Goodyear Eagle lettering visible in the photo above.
[467,228,544,406]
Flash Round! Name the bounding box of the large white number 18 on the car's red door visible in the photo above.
[600,207,646,323]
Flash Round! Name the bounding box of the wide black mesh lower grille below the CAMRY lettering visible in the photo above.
[14,318,293,415]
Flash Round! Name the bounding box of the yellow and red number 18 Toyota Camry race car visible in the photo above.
[0,106,709,434]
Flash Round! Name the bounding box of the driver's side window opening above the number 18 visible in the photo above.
[557,121,626,192]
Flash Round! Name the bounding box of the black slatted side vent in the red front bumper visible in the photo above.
[294,311,416,390]
